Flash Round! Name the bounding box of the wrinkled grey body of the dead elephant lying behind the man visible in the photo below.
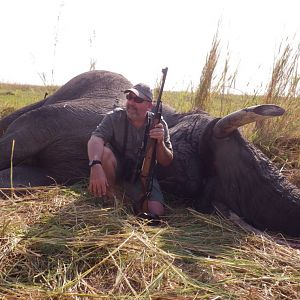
[0,71,300,236]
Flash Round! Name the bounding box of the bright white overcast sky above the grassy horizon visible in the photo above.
[0,0,300,93]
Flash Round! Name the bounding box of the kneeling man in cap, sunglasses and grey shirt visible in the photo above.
[88,83,173,216]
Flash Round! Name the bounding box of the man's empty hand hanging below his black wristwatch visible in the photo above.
[89,165,108,197]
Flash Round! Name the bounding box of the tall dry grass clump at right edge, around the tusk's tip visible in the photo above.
[252,43,300,170]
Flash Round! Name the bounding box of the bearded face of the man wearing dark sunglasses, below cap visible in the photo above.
[126,92,152,121]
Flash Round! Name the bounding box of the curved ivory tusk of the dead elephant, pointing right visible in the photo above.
[213,104,285,138]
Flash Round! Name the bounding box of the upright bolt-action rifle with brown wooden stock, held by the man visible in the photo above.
[137,68,168,219]
